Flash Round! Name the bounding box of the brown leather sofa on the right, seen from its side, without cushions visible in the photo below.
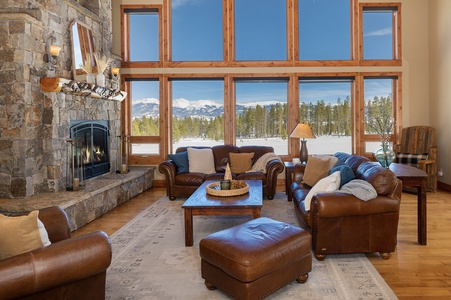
[290,153,402,260]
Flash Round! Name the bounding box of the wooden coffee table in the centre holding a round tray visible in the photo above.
[182,180,263,247]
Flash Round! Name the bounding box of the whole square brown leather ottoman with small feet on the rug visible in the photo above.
[199,218,312,299]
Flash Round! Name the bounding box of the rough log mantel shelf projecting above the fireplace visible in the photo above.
[41,77,127,101]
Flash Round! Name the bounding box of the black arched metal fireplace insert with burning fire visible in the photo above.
[70,120,110,179]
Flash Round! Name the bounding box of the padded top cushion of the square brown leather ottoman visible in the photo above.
[199,217,311,282]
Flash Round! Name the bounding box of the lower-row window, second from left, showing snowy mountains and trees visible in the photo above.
[170,78,224,151]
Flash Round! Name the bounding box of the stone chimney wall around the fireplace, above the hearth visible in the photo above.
[0,0,121,198]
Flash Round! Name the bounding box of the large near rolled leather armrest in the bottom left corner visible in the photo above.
[0,232,112,299]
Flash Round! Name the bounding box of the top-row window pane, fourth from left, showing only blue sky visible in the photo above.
[298,0,352,60]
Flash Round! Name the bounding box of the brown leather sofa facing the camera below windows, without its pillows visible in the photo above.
[158,145,284,200]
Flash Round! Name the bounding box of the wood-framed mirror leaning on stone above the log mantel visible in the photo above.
[71,21,96,81]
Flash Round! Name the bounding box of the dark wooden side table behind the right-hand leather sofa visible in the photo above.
[390,163,428,245]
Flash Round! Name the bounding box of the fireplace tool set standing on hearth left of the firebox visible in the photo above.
[66,139,85,191]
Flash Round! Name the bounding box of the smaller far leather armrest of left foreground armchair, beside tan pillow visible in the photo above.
[38,206,71,243]
